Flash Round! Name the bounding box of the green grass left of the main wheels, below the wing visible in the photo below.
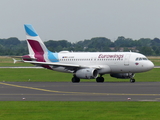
[0,68,72,82]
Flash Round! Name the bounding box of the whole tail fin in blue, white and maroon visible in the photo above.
[24,24,58,62]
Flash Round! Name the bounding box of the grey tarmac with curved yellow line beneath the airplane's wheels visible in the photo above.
[0,82,160,101]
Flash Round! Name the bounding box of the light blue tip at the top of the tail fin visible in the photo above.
[24,24,38,37]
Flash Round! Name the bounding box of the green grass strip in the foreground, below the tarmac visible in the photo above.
[0,101,160,120]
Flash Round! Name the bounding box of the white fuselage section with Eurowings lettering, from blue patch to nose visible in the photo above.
[48,52,154,74]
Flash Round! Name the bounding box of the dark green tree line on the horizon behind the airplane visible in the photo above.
[0,36,160,56]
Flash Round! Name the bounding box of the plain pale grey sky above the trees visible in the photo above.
[0,0,160,42]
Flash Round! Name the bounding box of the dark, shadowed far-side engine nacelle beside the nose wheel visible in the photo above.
[110,73,134,79]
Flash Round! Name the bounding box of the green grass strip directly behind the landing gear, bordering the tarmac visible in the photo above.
[0,68,160,82]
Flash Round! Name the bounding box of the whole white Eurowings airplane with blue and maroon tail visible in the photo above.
[22,24,154,83]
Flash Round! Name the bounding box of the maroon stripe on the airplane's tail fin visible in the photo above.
[28,39,46,62]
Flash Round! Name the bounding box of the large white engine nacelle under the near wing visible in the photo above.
[75,68,98,79]
